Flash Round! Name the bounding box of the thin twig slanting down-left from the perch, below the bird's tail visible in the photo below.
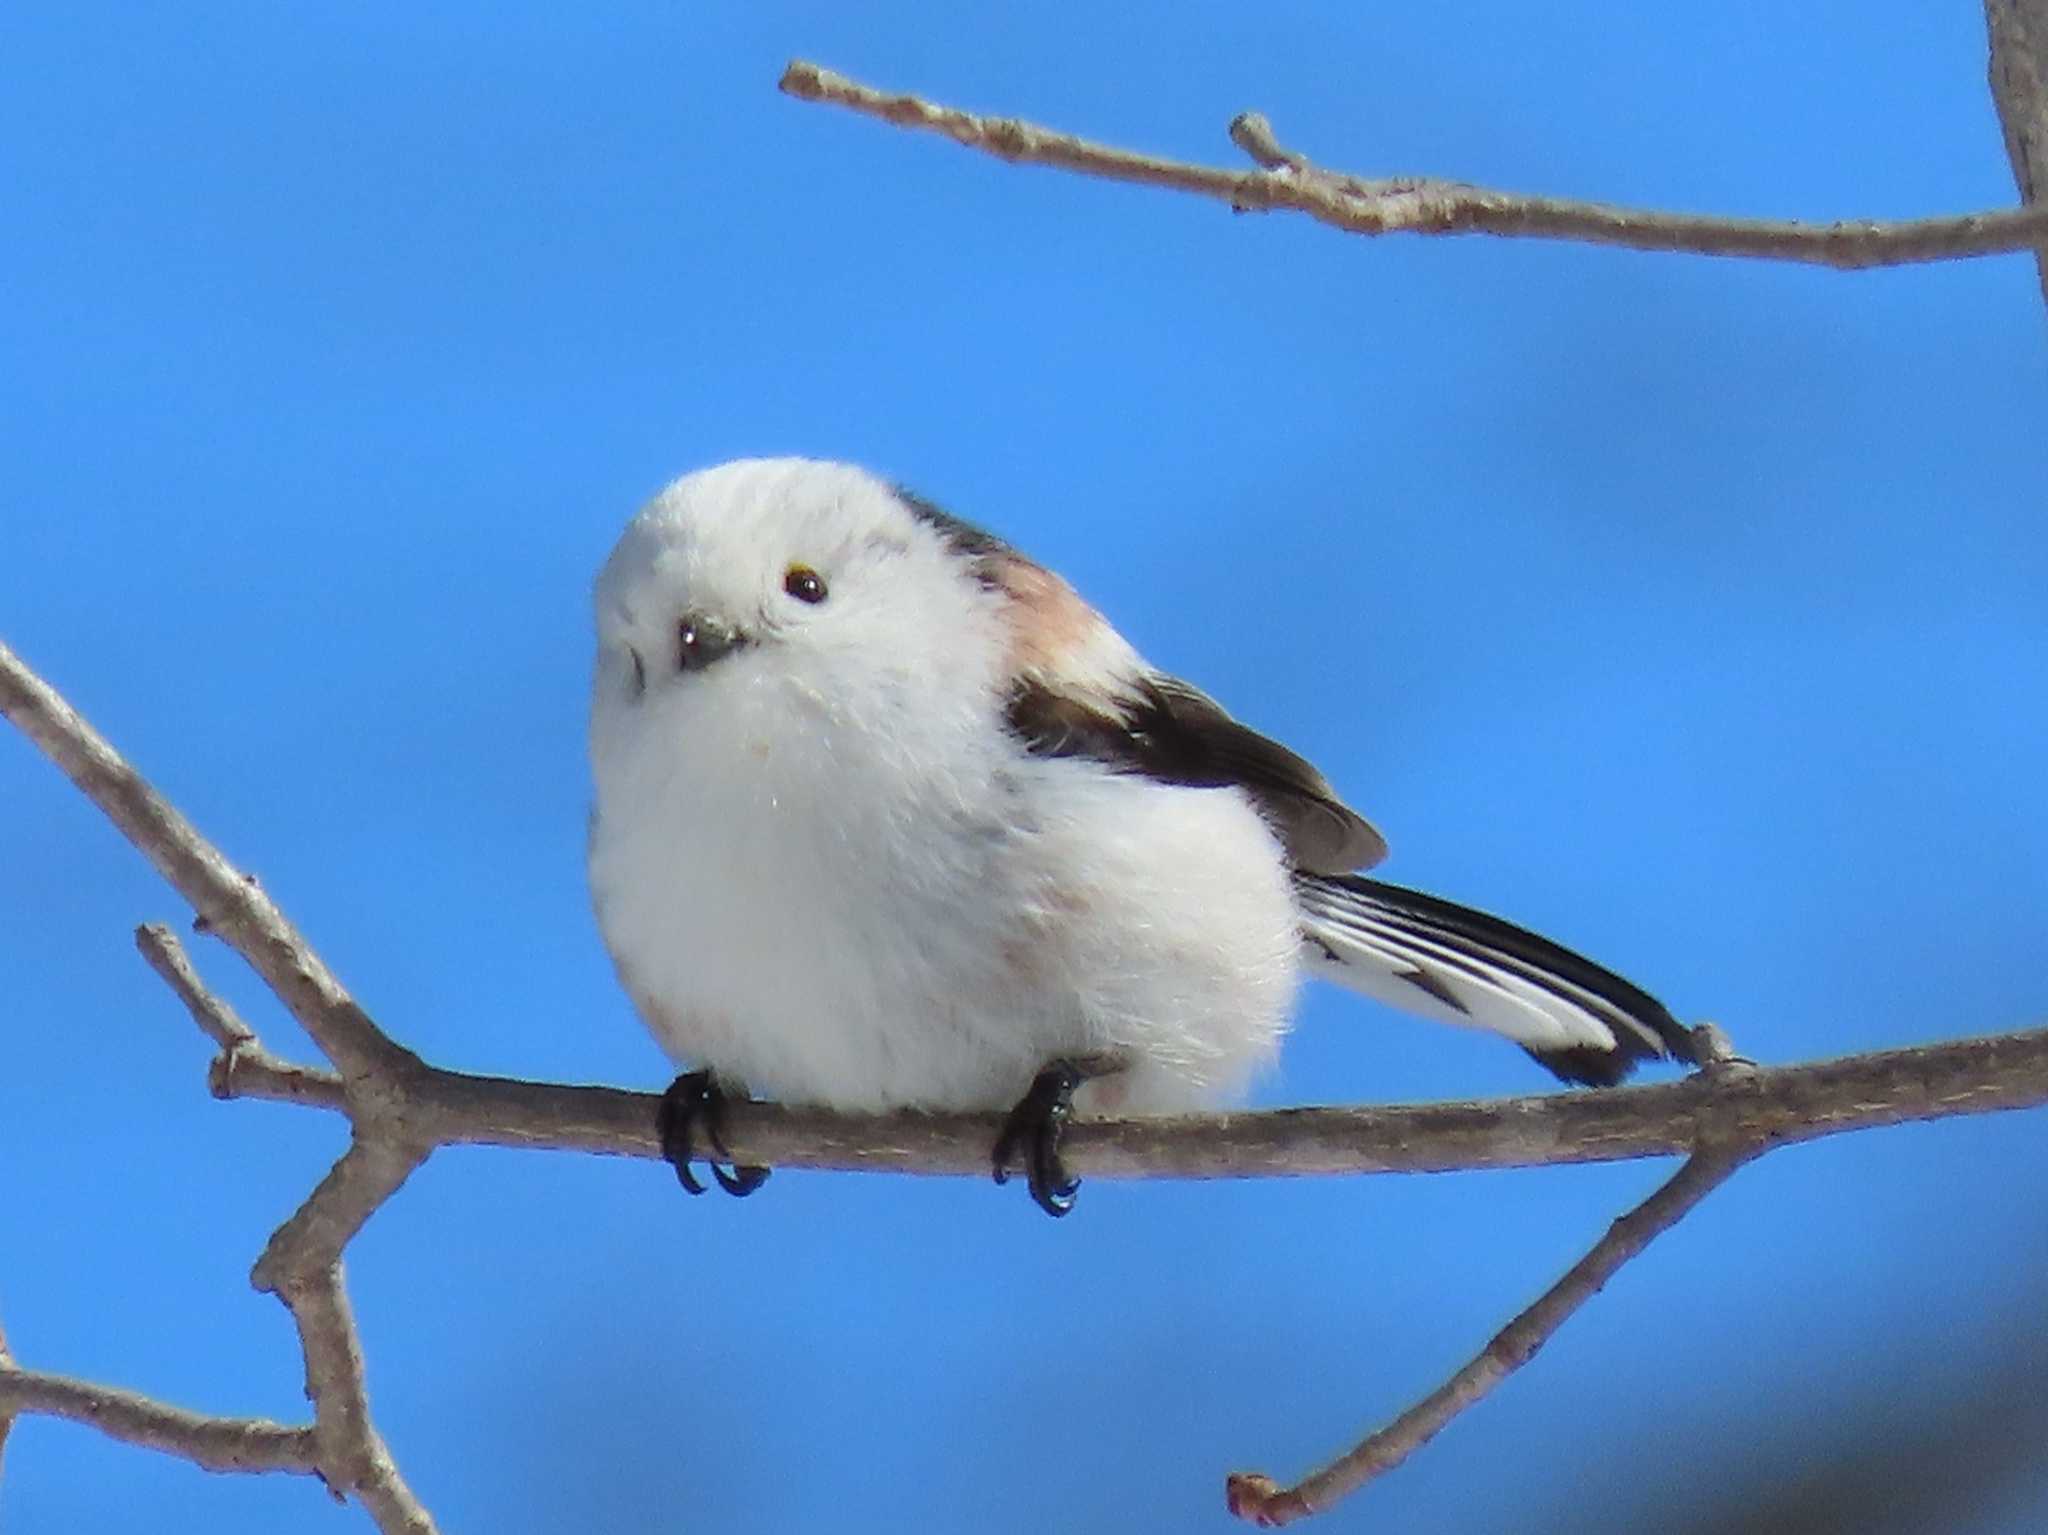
[1225,1144,1763,1527]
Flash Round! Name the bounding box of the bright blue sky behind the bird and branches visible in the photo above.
[0,0,2048,1535]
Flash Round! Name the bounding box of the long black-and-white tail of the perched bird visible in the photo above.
[1294,874,1694,1087]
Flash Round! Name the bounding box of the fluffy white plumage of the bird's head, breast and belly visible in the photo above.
[590,461,1300,1109]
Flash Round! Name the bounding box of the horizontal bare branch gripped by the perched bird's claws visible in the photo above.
[380,1029,2048,1179]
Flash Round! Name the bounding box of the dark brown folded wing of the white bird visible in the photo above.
[1008,671,1386,874]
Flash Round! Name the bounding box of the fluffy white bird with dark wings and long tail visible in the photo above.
[590,458,1692,1214]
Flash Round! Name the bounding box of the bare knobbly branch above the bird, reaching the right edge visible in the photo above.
[782,59,2048,268]
